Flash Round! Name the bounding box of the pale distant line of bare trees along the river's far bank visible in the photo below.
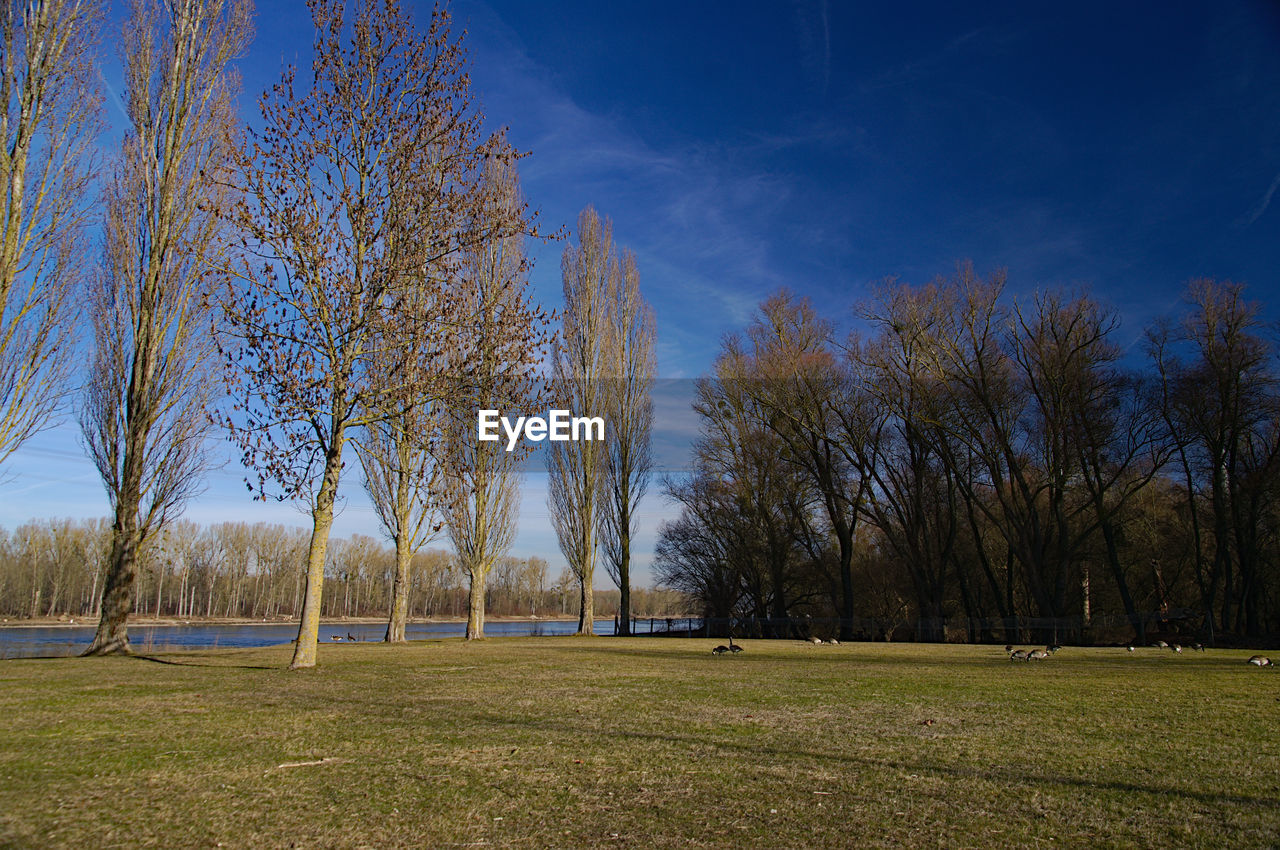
[0,520,689,618]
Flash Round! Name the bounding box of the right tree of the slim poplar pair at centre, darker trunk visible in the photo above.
[600,245,657,635]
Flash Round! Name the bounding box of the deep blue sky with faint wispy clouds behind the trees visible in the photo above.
[0,0,1280,586]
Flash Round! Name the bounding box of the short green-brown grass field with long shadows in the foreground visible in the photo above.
[0,638,1280,847]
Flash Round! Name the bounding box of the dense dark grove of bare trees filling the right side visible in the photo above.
[658,272,1280,640]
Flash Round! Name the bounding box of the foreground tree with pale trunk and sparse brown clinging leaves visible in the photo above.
[225,0,515,668]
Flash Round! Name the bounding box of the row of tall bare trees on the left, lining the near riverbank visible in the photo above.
[0,0,653,667]
